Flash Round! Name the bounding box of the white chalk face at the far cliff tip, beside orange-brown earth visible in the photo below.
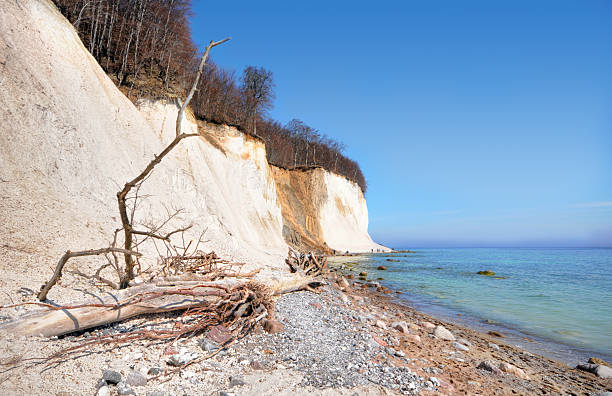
[319,170,389,252]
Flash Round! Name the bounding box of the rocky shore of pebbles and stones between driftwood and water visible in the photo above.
[0,274,612,396]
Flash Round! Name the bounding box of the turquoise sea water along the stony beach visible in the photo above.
[334,248,612,363]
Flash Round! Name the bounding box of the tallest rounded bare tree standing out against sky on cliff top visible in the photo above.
[241,66,274,135]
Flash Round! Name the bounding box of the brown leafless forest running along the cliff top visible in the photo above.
[54,0,367,192]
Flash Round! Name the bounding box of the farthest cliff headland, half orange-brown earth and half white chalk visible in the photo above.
[272,167,388,252]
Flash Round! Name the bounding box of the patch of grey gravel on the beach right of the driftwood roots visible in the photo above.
[231,289,431,394]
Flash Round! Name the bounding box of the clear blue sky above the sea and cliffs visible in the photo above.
[192,0,612,247]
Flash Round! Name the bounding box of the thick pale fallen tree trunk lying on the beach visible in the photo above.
[0,279,240,337]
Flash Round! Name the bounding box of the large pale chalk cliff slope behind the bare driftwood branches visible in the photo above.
[0,0,287,298]
